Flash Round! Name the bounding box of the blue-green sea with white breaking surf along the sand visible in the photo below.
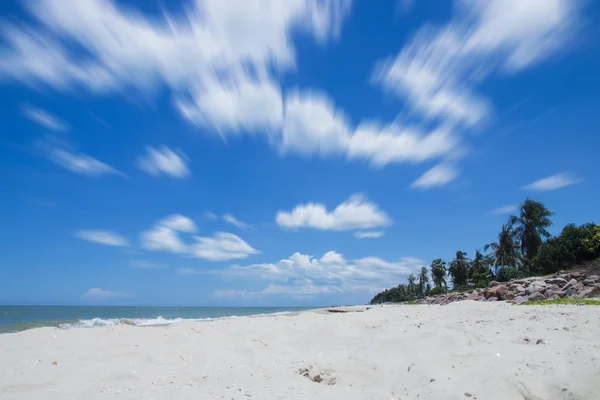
[0,306,314,333]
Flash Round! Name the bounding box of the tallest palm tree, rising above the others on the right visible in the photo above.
[510,199,554,261]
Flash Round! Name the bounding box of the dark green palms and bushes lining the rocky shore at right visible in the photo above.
[371,199,600,305]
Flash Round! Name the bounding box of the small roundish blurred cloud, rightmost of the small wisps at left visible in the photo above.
[137,146,190,178]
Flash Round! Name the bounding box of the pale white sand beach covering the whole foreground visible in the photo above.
[0,301,600,400]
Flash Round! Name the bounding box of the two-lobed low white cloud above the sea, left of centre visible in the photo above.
[140,214,260,261]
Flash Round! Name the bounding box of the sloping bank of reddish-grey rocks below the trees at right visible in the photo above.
[421,270,600,305]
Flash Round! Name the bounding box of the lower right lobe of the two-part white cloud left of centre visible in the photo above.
[190,232,260,261]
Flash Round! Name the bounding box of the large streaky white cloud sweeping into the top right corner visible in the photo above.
[373,0,579,126]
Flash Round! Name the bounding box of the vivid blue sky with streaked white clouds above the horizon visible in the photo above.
[0,0,600,305]
